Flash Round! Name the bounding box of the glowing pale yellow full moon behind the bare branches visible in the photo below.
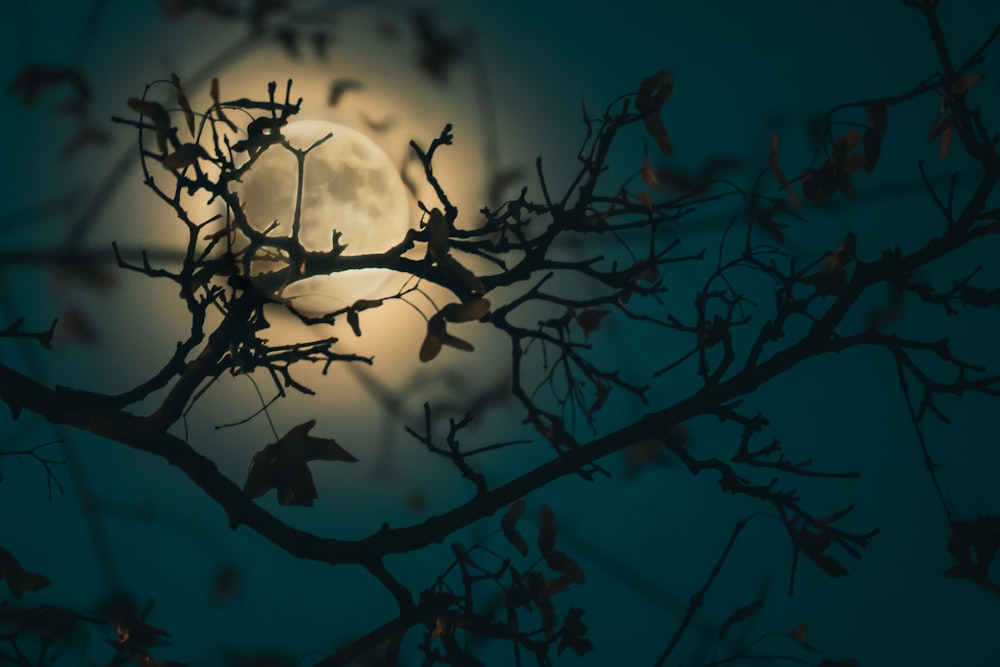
[240,121,410,313]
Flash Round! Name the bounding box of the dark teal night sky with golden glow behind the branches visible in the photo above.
[0,0,1000,666]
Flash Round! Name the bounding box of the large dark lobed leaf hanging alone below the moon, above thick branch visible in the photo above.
[243,419,357,507]
